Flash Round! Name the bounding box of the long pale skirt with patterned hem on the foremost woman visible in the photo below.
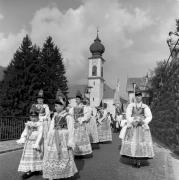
[43,131,77,179]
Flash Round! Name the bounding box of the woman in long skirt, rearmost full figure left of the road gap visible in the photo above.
[97,102,112,142]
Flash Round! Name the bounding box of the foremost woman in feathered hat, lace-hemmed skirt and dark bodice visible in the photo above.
[43,89,77,180]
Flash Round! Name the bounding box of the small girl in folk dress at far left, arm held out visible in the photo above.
[17,106,43,178]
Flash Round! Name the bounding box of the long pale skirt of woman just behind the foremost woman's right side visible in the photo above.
[74,123,92,156]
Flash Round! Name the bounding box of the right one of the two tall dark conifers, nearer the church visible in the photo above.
[39,37,68,107]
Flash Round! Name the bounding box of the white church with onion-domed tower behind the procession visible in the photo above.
[68,33,127,114]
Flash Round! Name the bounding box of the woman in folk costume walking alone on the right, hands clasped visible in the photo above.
[120,89,154,167]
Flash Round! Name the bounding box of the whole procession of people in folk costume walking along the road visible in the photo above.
[17,84,154,180]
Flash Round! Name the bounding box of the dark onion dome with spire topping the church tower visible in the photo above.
[90,33,105,57]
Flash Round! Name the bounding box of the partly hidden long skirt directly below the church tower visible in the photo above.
[86,117,99,143]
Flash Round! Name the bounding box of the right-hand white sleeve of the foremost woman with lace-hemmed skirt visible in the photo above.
[66,115,75,149]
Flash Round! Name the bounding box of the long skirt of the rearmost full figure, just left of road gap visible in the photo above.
[98,119,112,142]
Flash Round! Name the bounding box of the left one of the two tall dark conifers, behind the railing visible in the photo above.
[0,35,38,116]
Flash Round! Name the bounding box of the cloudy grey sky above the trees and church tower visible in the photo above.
[0,0,179,96]
